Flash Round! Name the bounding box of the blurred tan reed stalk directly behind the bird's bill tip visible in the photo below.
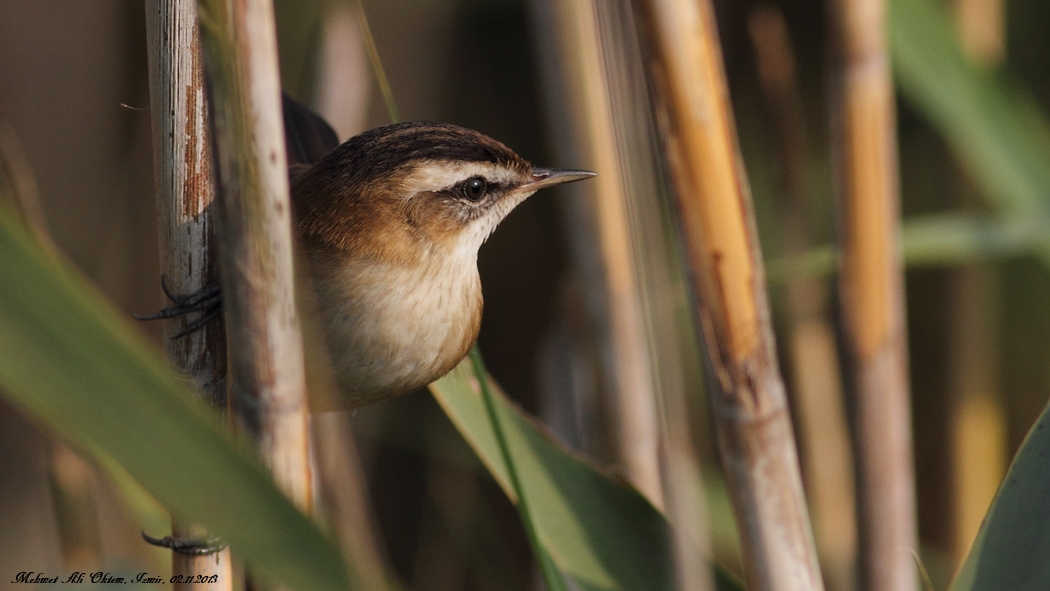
[537,0,664,507]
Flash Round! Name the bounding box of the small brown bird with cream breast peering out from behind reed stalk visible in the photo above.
[150,98,594,408]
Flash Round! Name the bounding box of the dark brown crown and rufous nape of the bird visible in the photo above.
[292,122,532,254]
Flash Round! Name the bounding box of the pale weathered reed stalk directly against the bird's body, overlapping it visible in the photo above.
[198,0,313,537]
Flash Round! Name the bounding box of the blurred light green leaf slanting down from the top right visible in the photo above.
[889,0,1050,262]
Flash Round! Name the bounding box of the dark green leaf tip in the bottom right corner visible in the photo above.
[951,406,1050,591]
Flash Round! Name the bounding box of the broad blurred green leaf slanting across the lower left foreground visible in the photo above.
[0,208,349,591]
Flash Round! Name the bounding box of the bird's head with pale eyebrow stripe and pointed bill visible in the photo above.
[292,123,594,262]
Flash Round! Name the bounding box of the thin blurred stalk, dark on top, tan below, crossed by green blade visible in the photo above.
[749,5,857,591]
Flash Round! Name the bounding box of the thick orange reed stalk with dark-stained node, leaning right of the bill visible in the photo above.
[635,0,823,591]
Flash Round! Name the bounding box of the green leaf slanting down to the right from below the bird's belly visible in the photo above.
[431,360,740,591]
